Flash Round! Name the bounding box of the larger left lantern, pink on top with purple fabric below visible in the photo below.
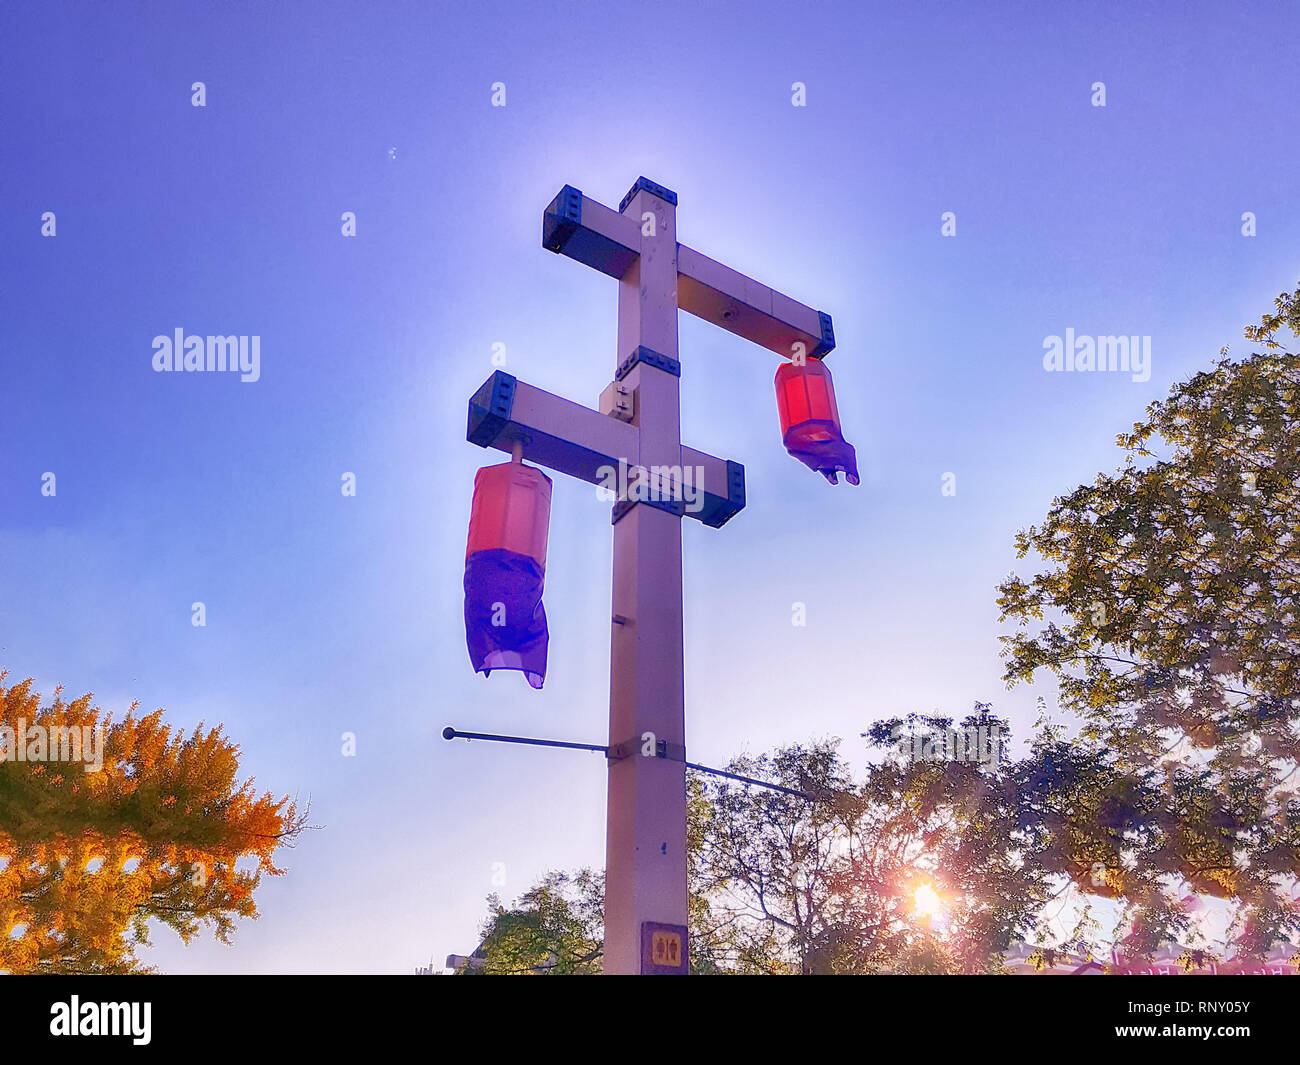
[465,462,551,688]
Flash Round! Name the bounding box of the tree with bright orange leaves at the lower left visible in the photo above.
[0,672,307,974]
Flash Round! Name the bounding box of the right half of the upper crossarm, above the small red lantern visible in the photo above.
[677,244,835,359]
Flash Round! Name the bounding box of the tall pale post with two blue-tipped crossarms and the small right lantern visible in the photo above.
[467,177,858,974]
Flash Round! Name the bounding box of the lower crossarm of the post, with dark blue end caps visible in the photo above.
[465,371,745,528]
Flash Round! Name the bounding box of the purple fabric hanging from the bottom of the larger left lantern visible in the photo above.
[465,547,550,688]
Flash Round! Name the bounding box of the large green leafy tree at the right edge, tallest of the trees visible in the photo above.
[998,290,1300,961]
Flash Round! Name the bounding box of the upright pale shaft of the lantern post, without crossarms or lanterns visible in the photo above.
[605,183,686,974]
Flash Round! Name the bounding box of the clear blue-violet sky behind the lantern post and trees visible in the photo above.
[0,3,1300,973]
